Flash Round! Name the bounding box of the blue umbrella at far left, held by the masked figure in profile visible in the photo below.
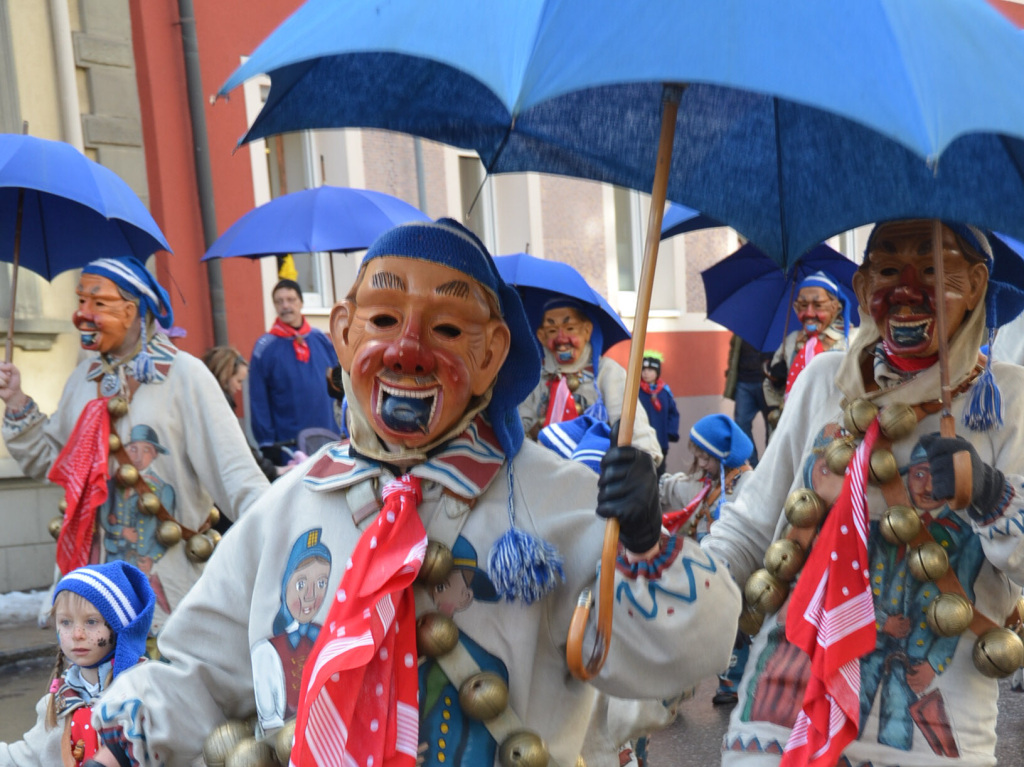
[0,133,171,360]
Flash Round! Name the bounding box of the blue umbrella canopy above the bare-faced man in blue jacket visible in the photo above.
[203,186,428,261]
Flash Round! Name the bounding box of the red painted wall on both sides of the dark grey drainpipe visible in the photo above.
[130,0,301,356]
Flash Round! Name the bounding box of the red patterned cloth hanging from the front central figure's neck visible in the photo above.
[291,474,427,767]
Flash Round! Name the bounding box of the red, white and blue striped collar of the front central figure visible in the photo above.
[302,414,505,499]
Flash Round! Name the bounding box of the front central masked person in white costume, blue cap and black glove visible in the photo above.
[88,219,740,767]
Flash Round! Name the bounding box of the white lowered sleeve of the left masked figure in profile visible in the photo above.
[175,356,268,519]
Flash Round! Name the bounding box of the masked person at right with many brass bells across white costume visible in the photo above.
[702,221,1024,767]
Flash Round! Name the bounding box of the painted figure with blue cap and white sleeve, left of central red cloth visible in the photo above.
[252,527,331,730]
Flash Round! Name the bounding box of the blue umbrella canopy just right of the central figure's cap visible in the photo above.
[495,253,630,355]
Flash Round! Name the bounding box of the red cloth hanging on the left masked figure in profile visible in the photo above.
[46,397,111,573]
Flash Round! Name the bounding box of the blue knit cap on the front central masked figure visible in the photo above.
[362,218,541,458]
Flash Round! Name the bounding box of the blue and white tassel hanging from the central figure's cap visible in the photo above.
[487,461,565,604]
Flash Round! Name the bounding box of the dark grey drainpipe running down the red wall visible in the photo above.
[178,0,227,346]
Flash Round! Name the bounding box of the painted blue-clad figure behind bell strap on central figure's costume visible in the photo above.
[419,536,509,767]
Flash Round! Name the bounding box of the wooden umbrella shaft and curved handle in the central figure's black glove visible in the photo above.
[565,84,685,681]
